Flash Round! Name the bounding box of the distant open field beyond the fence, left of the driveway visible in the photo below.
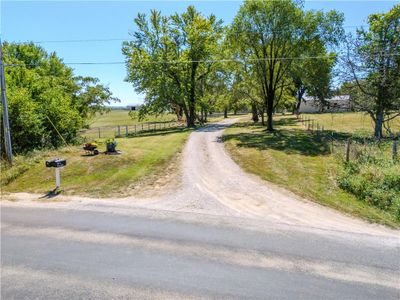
[89,109,176,128]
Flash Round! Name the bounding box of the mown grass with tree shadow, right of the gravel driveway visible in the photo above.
[224,114,400,227]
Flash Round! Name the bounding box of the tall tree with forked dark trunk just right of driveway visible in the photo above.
[231,0,343,131]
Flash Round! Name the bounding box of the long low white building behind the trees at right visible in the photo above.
[299,95,351,113]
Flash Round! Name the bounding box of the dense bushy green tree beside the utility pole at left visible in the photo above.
[1,43,116,153]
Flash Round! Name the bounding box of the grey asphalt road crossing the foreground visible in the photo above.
[1,205,400,299]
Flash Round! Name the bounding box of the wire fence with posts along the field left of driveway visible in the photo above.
[79,121,184,141]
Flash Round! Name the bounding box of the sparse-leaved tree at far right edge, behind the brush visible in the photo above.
[345,5,400,139]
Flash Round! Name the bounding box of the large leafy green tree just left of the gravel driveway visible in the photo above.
[122,6,222,127]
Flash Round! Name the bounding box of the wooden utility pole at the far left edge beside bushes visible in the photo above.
[0,39,12,164]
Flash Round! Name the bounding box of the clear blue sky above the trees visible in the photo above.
[0,0,400,106]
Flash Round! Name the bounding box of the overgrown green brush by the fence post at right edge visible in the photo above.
[337,151,400,220]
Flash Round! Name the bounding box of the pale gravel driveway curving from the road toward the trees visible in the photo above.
[3,119,395,235]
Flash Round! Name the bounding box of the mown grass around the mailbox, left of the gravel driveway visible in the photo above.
[2,129,191,197]
